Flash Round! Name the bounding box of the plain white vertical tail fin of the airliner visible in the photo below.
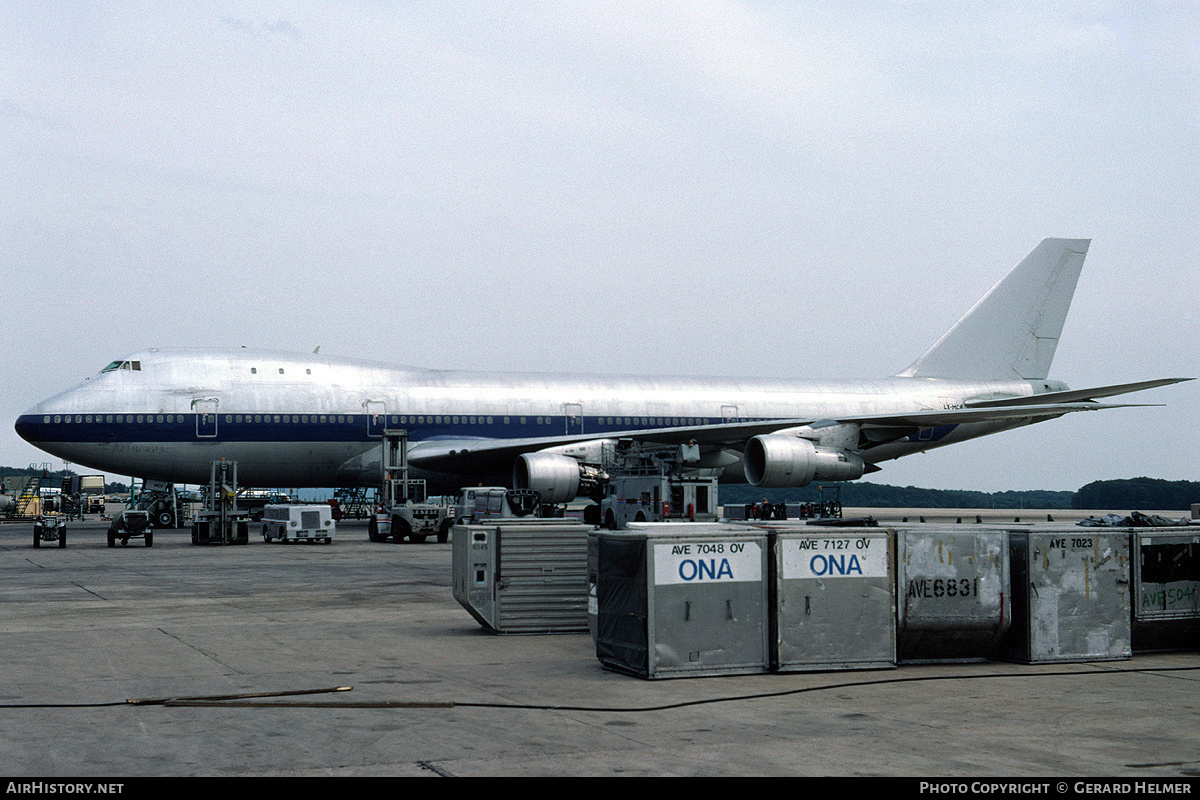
[900,239,1091,380]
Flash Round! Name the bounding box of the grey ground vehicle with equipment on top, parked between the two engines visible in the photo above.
[600,439,721,530]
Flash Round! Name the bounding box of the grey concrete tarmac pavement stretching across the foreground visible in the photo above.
[0,522,1200,777]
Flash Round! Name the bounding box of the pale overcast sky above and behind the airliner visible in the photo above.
[0,0,1200,501]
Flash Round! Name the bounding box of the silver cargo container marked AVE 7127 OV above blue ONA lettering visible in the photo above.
[770,527,896,672]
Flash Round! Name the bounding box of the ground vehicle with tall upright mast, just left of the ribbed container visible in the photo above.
[367,429,452,543]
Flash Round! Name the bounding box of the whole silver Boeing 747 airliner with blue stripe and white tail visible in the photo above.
[17,239,1188,503]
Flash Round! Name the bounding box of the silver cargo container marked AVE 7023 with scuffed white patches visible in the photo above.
[1002,527,1133,663]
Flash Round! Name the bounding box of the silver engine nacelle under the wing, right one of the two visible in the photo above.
[743,433,866,488]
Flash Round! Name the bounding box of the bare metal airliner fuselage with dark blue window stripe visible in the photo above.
[17,350,1063,487]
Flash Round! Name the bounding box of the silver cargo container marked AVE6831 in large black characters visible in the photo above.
[896,525,1012,662]
